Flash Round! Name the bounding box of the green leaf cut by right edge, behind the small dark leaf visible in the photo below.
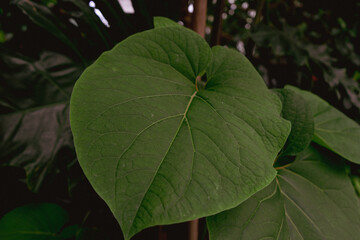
[286,86,360,164]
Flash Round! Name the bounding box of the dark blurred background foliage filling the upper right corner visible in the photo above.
[217,0,360,120]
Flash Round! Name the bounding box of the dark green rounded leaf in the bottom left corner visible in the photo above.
[0,203,69,240]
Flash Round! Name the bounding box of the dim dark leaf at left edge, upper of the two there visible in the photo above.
[0,51,83,113]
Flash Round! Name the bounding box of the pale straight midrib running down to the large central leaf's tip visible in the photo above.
[128,91,197,238]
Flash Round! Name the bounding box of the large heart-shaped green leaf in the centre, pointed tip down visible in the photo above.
[70,23,290,239]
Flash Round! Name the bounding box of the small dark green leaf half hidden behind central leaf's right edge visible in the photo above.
[275,89,314,156]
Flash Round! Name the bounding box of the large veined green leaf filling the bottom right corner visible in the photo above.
[207,144,360,240]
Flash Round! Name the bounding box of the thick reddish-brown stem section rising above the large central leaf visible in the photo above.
[192,0,207,37]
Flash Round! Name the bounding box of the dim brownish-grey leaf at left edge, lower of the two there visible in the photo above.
[0,103,73,192]
